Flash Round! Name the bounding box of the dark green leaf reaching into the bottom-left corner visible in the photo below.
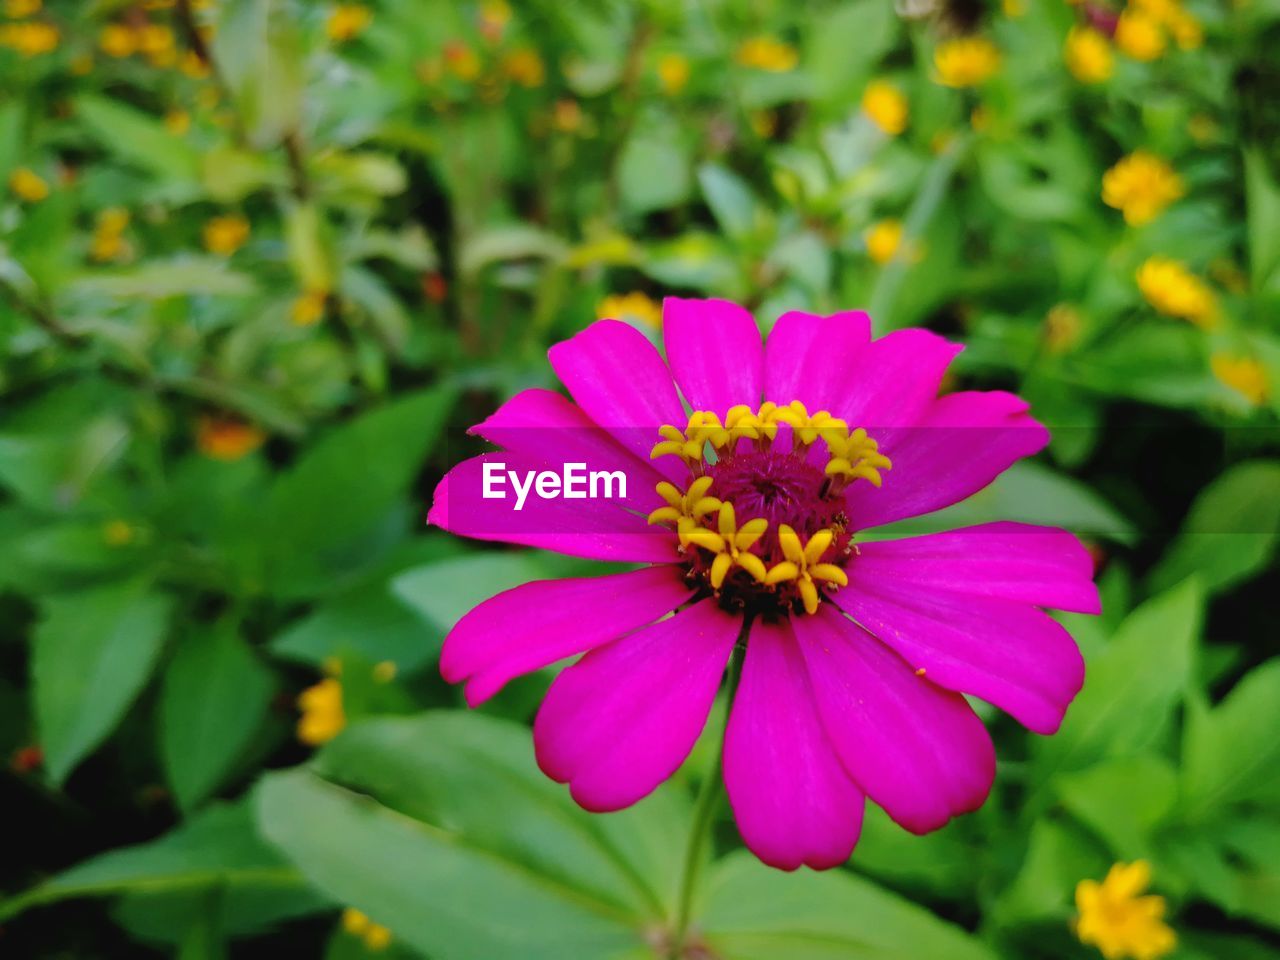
[0,804,324,938]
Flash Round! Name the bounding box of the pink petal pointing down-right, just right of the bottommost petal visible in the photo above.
[794,604,996,833]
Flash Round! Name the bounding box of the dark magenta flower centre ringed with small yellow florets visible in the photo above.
[649,401,892,616]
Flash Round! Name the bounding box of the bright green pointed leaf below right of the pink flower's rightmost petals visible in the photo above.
[1036,577,1204,782]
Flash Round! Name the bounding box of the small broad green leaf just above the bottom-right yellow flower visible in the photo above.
[1053,754,1178,860]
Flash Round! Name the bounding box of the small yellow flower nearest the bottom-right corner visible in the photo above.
[1075,860,1178,960]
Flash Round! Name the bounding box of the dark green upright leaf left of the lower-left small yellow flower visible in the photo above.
[160,622,275,810]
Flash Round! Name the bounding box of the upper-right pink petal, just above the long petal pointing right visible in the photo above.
[832,329,964,436]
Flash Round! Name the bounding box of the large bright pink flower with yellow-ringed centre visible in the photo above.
[429,298,1100,869]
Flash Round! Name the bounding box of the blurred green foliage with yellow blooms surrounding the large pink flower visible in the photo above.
[0,0,1280,960]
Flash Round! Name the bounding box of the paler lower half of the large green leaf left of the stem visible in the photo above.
[257,769,643,960]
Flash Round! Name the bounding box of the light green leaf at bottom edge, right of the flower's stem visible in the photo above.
[696,851,996,960]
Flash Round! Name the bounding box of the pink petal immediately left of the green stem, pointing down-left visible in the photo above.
[534,600,741,812]
